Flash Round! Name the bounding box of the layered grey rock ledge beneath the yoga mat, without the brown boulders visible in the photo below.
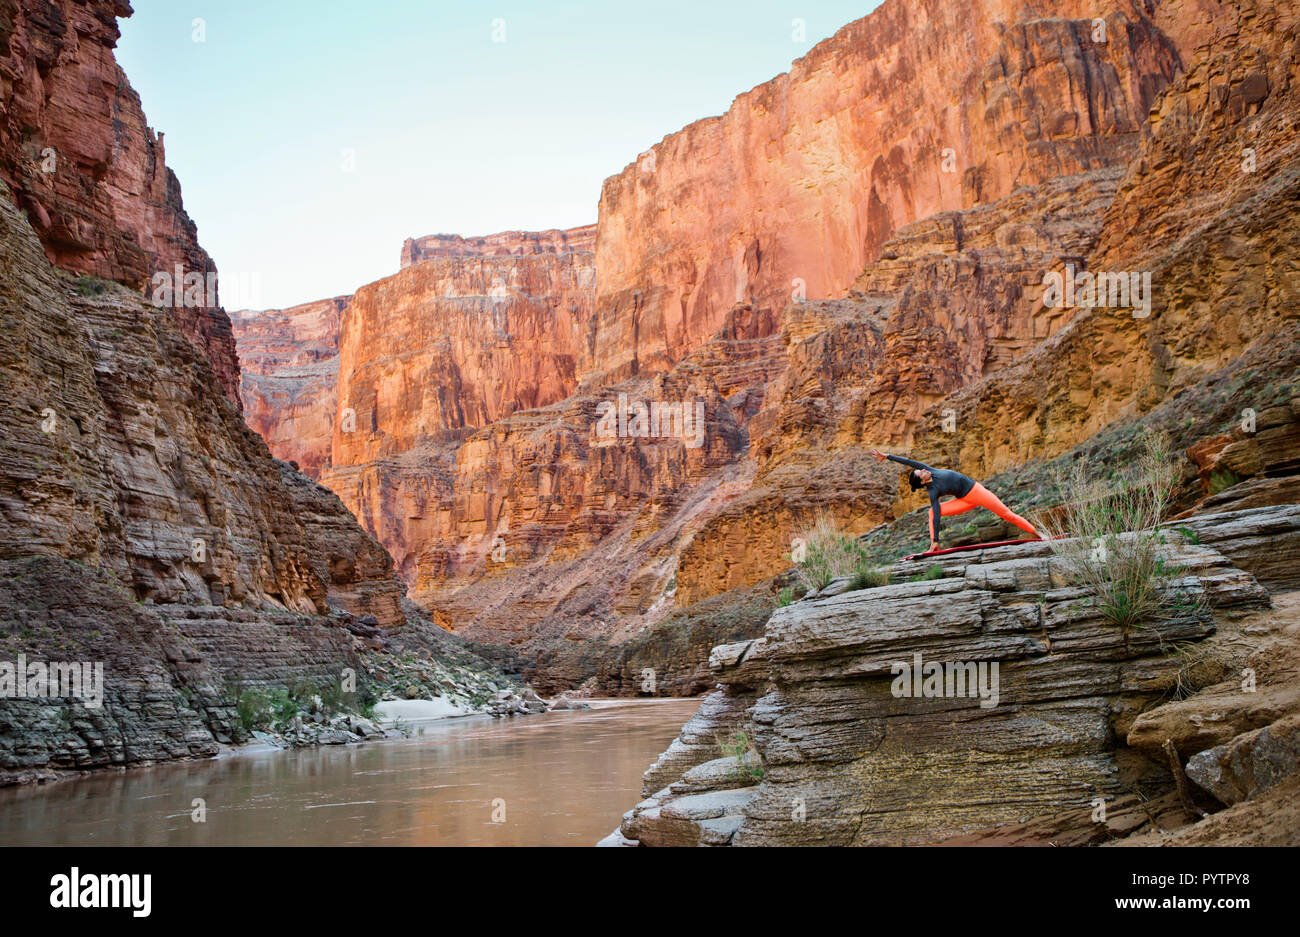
[621,522,1269,845]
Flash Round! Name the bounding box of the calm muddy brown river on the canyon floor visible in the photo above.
[0,699,699,846]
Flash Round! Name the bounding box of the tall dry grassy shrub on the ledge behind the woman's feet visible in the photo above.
[1039,433,1201,628]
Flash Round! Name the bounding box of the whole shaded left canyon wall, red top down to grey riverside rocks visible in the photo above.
[0,0,511,784]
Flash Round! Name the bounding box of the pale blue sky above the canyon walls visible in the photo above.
[117,0,879,309]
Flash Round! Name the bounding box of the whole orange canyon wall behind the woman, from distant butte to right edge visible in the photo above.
[233,1,1297,693]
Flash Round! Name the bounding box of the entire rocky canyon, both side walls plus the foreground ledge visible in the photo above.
[0,0,1300,845]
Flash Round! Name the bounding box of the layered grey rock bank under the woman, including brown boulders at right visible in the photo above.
[606,504,1300,846]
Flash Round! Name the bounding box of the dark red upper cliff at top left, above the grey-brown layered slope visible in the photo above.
[0,0,239,405]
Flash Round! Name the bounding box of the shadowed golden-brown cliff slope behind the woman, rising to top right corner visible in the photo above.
[681,4,1300,597]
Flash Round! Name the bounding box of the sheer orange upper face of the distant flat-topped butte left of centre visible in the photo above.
[332,226,595,467]
